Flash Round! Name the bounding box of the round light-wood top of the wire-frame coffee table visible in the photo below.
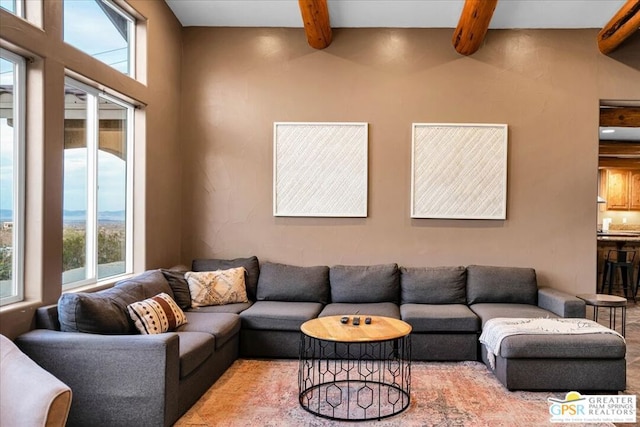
[300,314,411,342]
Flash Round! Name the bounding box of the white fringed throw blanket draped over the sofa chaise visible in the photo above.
[480,317,624,369]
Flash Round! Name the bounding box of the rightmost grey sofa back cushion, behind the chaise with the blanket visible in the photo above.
[467,265,538,305]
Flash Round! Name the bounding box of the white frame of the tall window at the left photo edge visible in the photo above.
[0,48,27,307]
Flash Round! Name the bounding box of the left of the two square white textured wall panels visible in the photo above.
[273,122,368,217]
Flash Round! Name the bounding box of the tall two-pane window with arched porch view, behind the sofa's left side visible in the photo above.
[62,79,133,289]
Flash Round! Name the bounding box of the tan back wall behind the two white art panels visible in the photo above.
[180,28,640,293]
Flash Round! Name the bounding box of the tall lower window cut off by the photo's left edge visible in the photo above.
[0,49,26,305]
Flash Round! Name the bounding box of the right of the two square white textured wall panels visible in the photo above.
[411,123,507,220]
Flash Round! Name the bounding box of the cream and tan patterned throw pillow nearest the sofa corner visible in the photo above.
[184,267,249,307]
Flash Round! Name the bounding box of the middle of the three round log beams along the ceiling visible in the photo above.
[452,0,500,55]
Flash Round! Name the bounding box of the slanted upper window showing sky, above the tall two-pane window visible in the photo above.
[62,0,135,77]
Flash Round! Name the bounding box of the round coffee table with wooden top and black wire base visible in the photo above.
[298,315,411,421]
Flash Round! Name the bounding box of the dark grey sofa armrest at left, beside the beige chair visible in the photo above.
[15,329,180,426]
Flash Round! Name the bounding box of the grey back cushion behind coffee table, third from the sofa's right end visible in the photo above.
[329,264,400,304]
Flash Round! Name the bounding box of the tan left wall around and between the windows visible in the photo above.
[0,0,182,337]
